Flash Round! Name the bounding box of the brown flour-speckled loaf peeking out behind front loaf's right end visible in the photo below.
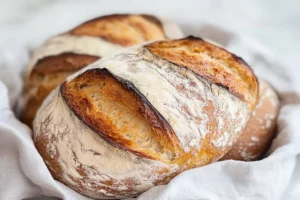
[221,79,279,161]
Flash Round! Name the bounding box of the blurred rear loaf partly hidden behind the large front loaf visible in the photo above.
[21,14,182,126]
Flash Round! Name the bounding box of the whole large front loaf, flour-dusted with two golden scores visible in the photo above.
[33,37,258,198]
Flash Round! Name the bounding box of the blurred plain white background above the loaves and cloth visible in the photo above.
[0,0,300,69]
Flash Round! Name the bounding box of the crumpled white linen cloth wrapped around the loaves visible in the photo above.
[0,3,300,200]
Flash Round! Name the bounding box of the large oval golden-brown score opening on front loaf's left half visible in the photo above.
[61,69,180,162]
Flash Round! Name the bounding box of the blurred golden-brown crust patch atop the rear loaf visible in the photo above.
[69,14,166,46]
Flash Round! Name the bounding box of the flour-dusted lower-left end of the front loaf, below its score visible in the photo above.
[34,88,182,199]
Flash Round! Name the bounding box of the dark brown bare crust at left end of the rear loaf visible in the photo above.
[21,53,99,127]
